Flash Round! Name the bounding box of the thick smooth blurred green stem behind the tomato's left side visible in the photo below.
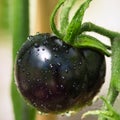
[11,0,35,120]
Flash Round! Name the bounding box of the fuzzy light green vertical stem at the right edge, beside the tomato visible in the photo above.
[99,36,120,120]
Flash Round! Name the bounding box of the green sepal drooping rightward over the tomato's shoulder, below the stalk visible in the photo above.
[72,34,111,56]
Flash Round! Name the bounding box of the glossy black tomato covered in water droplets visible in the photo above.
[15,34,105,113]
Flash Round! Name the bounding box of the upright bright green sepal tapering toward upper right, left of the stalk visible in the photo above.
[63,0,92,43]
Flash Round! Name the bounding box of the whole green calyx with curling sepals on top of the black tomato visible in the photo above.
[50,0,111,56]
